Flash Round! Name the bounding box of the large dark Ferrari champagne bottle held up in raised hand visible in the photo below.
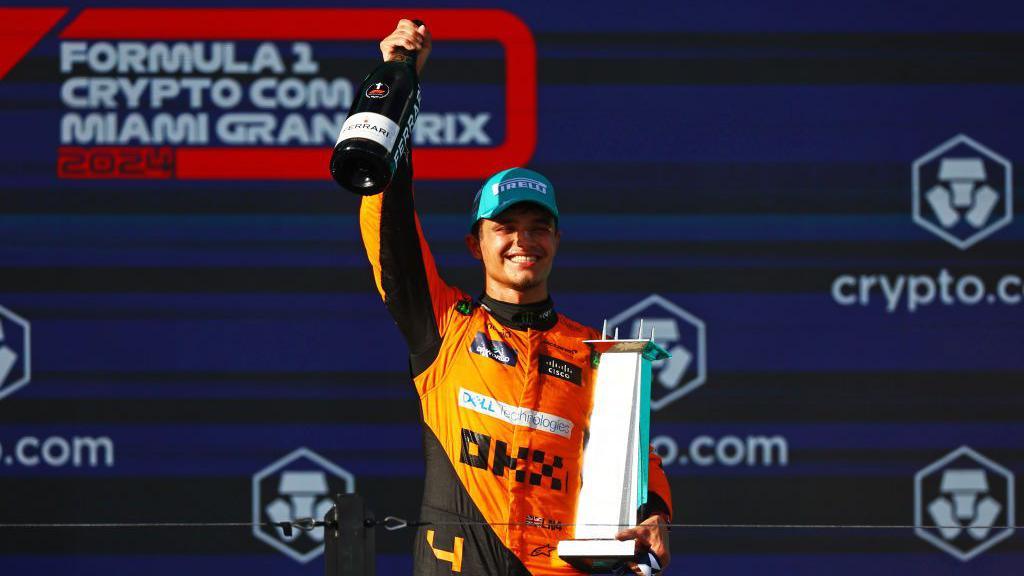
[331,26,422,196]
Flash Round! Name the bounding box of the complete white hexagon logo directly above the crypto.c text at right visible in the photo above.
[912,134,1014,250]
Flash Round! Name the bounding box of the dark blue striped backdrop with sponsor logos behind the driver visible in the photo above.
[0,0,1024,576]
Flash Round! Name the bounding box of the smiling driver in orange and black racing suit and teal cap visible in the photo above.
[359,19,672,576]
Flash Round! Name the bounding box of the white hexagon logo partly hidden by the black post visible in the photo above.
[252,448,355,564]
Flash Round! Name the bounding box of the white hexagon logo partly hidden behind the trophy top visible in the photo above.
[608,294,708,410]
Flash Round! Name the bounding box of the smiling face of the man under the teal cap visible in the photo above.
[466,202,561,297]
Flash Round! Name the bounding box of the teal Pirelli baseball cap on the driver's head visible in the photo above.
[469,168,558,228]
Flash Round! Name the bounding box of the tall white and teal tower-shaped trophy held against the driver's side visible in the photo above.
[558,320,671,572]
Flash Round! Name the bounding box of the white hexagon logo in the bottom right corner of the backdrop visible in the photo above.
[913,446,1016,562]
